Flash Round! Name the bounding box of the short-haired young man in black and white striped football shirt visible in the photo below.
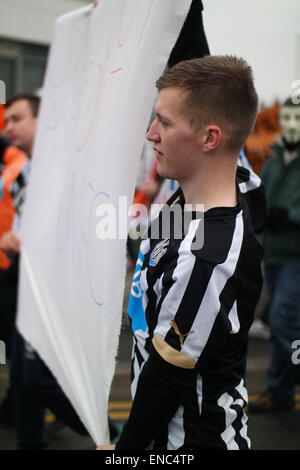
[102,56,265,450]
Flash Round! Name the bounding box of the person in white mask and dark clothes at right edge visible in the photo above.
[249,99,300,412]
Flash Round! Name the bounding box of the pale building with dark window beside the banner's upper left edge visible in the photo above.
[0,0,92,99]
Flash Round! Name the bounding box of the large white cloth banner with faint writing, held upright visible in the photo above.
[17,0,191,444]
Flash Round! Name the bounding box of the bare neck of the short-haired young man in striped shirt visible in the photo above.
[178,154,238,212]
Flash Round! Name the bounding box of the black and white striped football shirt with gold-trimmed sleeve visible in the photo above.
[116,167,266,450]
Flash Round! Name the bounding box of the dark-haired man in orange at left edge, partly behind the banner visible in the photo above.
[0,94,39,424]
